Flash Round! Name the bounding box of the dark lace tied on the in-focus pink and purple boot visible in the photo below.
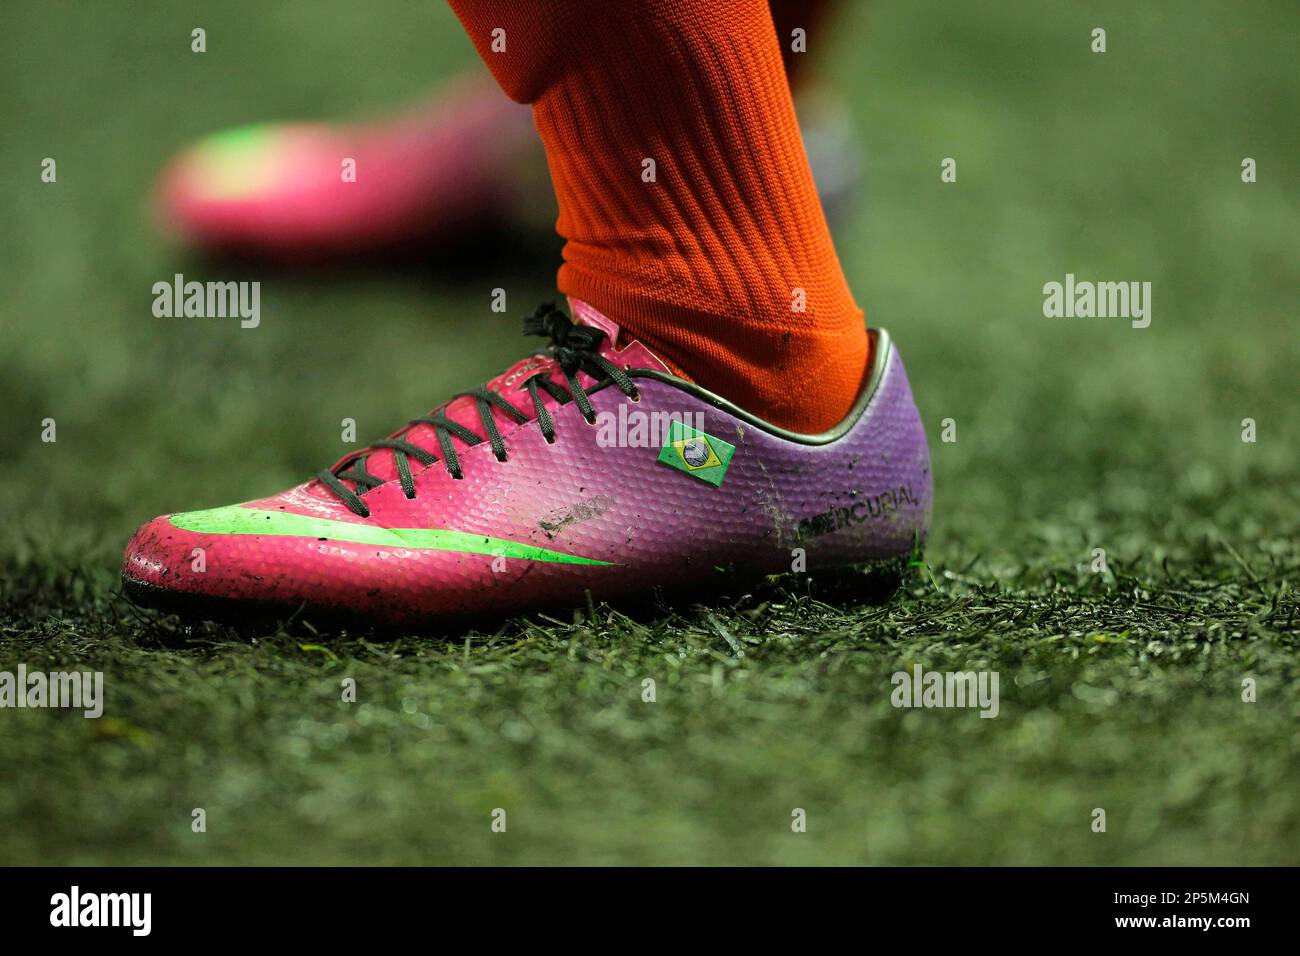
[316,302,638,518]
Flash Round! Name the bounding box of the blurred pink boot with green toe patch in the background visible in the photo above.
[156,78,538,263]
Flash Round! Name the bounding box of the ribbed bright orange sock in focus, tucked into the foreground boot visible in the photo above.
[451,0,870,432]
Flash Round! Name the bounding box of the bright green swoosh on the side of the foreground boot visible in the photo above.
[170,505,614,564]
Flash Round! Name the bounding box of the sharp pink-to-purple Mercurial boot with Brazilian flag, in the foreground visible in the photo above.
[122,299,932,627]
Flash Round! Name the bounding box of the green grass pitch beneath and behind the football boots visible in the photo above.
[0,0,1300,865]
